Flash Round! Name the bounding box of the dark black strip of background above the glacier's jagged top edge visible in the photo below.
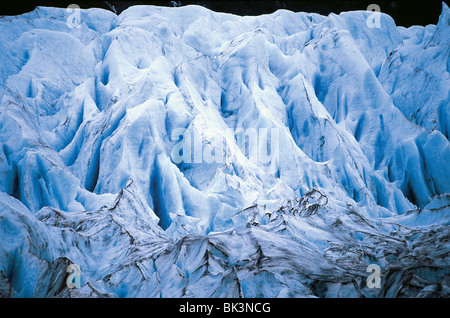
[0,0,448,27]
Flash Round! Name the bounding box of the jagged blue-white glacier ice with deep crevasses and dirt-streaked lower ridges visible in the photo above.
[0,3,450,297]
